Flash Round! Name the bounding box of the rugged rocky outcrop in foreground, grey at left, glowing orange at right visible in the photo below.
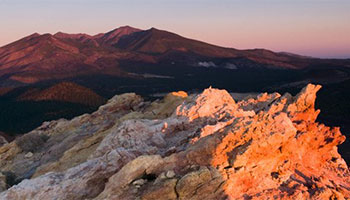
[0,84,350,199]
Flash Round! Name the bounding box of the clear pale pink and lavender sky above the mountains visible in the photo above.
[0,0,350,58]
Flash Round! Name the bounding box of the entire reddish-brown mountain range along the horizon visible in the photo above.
[0,26,350,85]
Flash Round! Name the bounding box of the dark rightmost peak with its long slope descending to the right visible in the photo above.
[115,28,326,69]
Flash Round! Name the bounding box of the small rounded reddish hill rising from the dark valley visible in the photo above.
[17,82,105,106]
